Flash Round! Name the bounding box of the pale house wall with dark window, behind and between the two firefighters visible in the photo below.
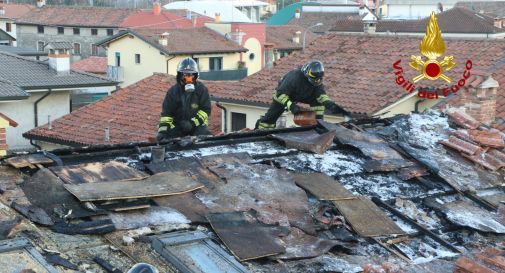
[221,102,343,132]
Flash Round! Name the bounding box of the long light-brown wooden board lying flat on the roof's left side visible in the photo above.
[65,172,203,202]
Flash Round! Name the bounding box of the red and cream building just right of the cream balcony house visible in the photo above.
[205,22,266,75]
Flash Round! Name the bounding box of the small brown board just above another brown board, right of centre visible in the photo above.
[292,173,357,200]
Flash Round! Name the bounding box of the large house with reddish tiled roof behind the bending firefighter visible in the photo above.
[204,34,505,132]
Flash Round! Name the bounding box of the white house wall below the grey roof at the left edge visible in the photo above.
[0,91,70,150]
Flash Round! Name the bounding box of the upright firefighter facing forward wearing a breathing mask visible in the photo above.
[157,58,211,141]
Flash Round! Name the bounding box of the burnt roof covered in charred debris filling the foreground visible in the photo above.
[0,112,505,273]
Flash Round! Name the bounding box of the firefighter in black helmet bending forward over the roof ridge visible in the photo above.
[255,60,349,129]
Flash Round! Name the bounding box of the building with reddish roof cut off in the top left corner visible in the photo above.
[0,1,35,46]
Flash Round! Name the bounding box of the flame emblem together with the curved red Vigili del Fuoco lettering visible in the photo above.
[393,12,473,99]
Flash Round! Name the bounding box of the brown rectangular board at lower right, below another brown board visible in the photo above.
[333,197,405,237]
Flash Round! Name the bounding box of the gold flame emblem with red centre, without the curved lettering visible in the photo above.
[409,12,456,83]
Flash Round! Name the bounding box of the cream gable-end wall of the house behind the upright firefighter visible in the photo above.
[107,36,167,87]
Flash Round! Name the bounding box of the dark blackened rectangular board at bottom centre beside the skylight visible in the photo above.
[207,212,285,261]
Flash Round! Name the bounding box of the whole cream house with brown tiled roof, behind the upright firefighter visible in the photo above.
[97,28,248,87]
